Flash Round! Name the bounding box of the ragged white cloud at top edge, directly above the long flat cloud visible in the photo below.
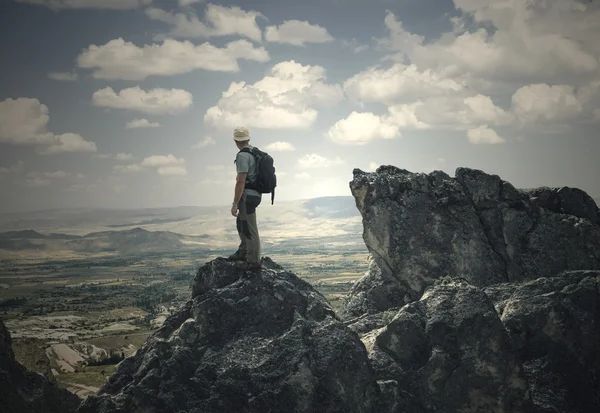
[146,4,262,42]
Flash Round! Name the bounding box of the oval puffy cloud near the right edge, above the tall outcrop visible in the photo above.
[512,84,583,123]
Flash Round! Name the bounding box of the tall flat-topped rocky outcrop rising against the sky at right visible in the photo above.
[341,166,600,318]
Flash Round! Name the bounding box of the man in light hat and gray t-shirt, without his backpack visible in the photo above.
[229,127,262,270]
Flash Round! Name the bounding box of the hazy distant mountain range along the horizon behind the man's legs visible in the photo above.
[0,196,364,258]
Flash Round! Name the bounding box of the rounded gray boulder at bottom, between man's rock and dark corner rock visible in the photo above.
[349,279,533,413]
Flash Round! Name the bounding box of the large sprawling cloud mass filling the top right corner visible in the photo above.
[379,4,600,82]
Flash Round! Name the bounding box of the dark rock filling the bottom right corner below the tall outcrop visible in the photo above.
[485,271,600,413]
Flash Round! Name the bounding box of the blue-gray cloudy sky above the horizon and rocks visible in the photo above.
[0,0,600,212]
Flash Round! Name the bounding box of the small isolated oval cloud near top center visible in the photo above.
[265,20,333,46]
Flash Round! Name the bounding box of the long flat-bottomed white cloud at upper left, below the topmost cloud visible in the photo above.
[77,38,270,80]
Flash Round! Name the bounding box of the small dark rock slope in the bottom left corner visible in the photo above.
[0,320,80,413]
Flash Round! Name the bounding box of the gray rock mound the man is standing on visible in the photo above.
[79,259,380,413]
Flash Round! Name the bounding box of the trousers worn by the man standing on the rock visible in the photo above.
[236,194,261,264]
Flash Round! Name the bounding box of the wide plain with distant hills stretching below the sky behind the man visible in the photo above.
[0,197,368,398]
